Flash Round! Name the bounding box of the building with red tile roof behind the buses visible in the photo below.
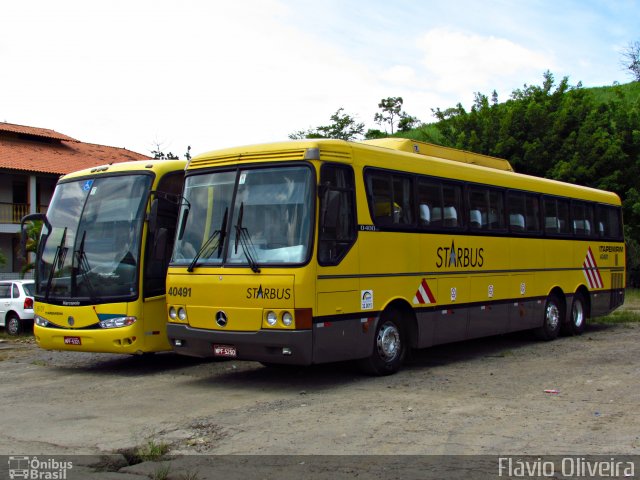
[0,122,150,276]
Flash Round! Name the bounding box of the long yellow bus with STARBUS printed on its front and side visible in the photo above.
[167,139,625,375]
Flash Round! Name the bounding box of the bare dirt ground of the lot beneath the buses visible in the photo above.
[0,323,640,478]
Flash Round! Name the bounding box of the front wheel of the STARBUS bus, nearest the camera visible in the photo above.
[360,308,407,376]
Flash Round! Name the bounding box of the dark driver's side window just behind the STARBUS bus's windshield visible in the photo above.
[318,164,357,265]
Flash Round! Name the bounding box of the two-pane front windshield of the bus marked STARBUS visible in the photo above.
[173,166,314,271]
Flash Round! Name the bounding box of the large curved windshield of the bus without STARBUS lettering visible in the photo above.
[36,174,153,302]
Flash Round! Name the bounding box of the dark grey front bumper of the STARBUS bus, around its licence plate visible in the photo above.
[167,323,313,365]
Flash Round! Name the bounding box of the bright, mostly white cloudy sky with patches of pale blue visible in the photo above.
[0,0,640,158]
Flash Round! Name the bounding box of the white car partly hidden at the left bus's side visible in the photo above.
[0,280,35,335]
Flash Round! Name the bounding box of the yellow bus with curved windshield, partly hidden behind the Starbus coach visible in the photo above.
[22,160,186,354]
